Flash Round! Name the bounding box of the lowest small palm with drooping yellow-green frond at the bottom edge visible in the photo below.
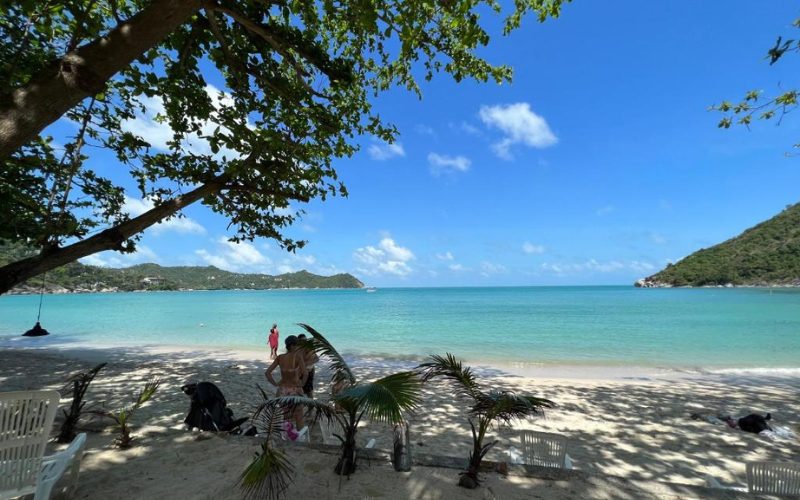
[239,387,333,500]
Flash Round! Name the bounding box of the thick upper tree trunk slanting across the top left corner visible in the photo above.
[0,0,202,159]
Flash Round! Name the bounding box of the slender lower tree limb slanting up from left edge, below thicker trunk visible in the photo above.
[0,180,224,295]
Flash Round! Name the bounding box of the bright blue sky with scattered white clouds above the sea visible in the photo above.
[61,0,800,286]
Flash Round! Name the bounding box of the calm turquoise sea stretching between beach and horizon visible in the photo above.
[0,286,800,371]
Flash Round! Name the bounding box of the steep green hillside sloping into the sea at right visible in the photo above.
[635,199,800,288]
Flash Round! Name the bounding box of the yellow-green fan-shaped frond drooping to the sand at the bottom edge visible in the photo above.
[239,446,294,500]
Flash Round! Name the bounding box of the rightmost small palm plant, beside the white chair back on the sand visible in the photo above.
[418,353,555,488]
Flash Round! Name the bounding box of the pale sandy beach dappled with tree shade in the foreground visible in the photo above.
[0,341,800,498]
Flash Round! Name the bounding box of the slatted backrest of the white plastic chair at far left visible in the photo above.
[0,391,59,499]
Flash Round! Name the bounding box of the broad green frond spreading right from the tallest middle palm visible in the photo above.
[334,372,422,424]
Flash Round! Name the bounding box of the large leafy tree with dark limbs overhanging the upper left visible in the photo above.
[0,0,562,293]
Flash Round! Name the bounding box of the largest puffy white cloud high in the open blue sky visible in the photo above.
[479,102,558,160]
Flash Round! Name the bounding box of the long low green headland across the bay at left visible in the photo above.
[0,245,364,294]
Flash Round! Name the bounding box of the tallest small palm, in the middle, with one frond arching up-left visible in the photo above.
[300,323,422,476]
